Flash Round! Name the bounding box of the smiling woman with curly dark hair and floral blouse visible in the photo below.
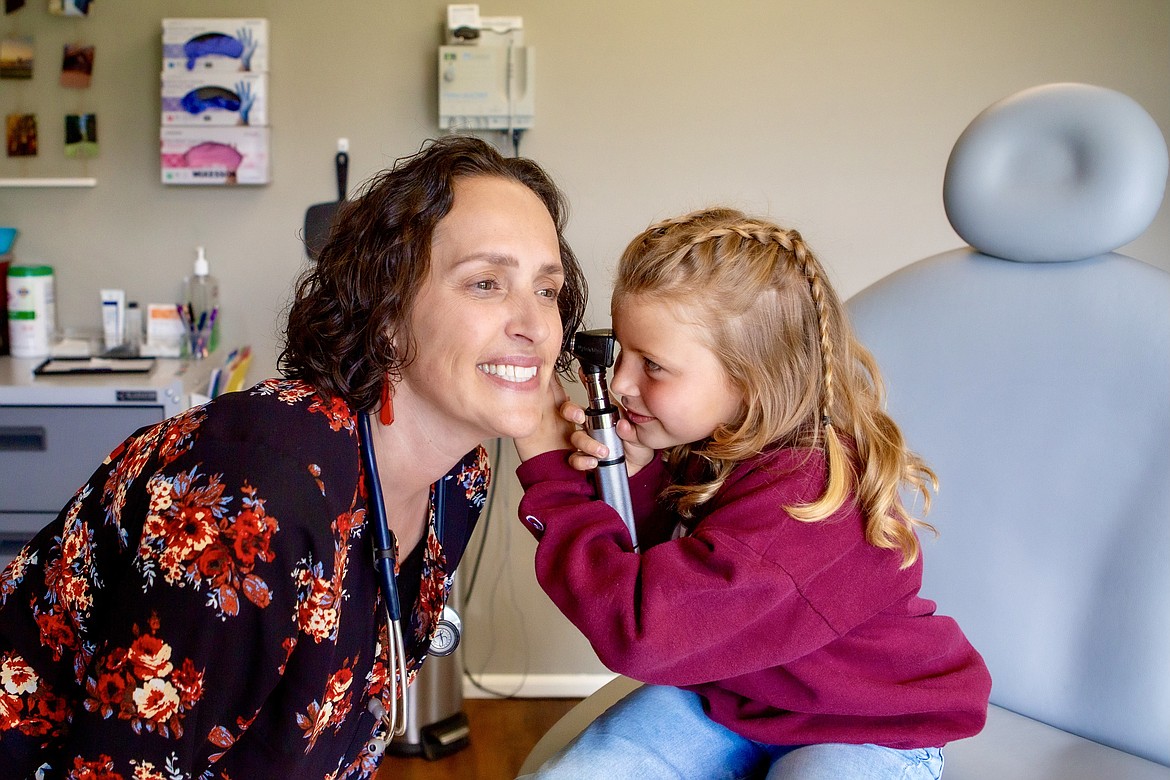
[0,137,585,780]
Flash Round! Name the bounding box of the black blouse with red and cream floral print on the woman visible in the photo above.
[0,379,489,780]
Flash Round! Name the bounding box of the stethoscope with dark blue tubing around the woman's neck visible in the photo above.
[358,412,461,755]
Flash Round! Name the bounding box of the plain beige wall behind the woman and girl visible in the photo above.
[0,0,1170,684]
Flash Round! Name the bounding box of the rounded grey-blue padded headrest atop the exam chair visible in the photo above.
[943,84,1168,262]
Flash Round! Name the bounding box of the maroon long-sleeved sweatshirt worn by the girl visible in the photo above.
[517,449,991,750]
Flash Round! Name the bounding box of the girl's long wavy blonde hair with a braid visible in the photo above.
[613,208,937,568]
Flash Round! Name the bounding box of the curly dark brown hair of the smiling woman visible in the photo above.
[278,136,587,409]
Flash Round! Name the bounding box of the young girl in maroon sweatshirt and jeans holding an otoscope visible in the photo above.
[517,208,991,780]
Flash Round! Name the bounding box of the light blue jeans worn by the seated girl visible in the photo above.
[524,685,943,780]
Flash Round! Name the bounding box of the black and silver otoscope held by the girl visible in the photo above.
[569,327,638,552]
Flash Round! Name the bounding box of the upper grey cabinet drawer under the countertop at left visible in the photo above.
[0,406,163,519]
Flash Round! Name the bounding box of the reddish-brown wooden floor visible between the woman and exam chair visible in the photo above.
[377,699,580,780]
